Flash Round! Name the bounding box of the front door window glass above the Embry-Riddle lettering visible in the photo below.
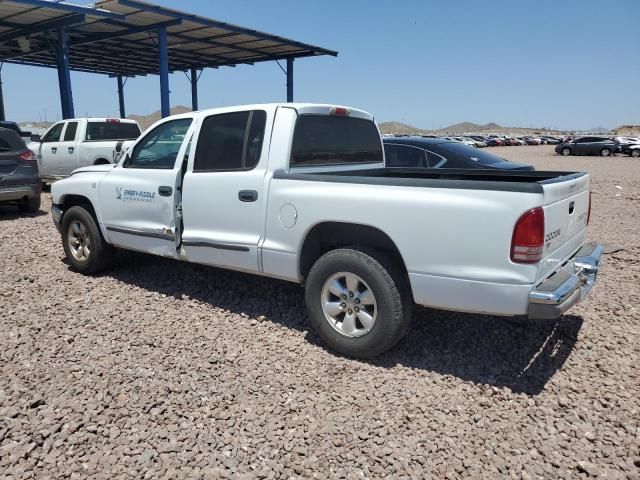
[124,118,192,170]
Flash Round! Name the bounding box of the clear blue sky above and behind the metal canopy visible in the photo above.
[3,0,640,129]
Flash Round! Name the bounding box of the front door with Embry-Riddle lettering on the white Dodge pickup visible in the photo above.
[100,118,192,257]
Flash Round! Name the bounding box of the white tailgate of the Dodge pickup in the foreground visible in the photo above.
[538,173,589,279]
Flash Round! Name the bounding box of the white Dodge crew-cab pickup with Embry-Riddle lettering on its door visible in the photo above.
[52,104,603,357]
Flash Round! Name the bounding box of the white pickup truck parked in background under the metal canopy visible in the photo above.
[28,118,140,181]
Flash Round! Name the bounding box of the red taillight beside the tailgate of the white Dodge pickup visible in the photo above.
[511,207,544,263]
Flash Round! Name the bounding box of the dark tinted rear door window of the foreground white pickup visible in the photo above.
[193,110,267,172]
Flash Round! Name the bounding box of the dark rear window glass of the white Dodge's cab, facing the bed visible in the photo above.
[291,115,383,167]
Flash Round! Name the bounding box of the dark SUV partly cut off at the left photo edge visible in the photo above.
[0,128,42,213]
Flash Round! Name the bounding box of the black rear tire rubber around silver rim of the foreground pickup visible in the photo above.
[305,248,413,358]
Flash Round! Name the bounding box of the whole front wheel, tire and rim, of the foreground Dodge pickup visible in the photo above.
[60,207,115,275]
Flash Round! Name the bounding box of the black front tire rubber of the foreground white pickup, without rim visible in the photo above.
[60,206,115,275]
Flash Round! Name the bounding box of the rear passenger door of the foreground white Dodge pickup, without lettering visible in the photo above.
[182,110,271,272]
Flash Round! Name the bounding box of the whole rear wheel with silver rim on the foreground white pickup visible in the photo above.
[305,248,412,358]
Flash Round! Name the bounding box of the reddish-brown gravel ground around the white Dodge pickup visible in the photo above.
[0,146,640,480]
